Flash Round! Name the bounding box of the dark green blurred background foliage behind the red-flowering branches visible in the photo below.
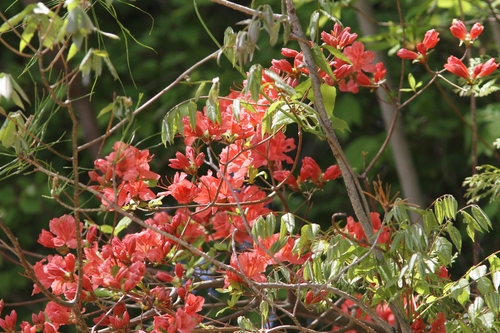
[0,0,500,318]
